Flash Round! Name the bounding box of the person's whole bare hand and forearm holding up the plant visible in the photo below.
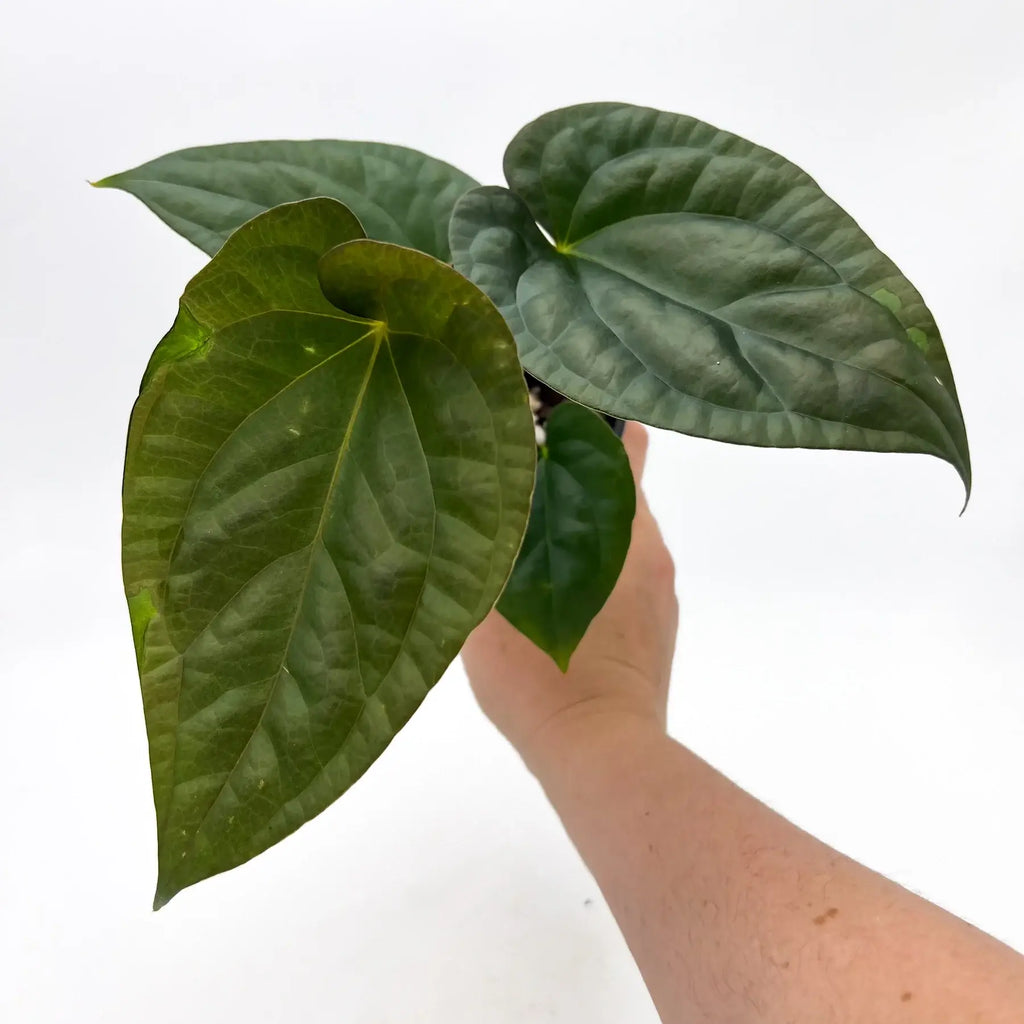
[463,424,1024,1024]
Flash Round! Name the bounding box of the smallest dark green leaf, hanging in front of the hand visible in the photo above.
[498,401,636,671]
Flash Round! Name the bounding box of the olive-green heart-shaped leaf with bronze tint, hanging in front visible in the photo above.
[123,200,536,906]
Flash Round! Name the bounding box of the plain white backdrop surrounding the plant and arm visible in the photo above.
[0,0,1024,1024]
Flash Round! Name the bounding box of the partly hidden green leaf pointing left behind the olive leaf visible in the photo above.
[95,139,476,262]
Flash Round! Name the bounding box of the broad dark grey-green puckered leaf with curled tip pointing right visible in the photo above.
[451,103,971,499]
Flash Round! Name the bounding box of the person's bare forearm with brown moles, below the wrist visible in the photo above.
[527,717,1024,1024]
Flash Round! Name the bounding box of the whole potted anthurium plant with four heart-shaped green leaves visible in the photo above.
[96,103,971,906]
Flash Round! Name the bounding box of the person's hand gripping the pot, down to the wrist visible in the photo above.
[462,423,679,770]
